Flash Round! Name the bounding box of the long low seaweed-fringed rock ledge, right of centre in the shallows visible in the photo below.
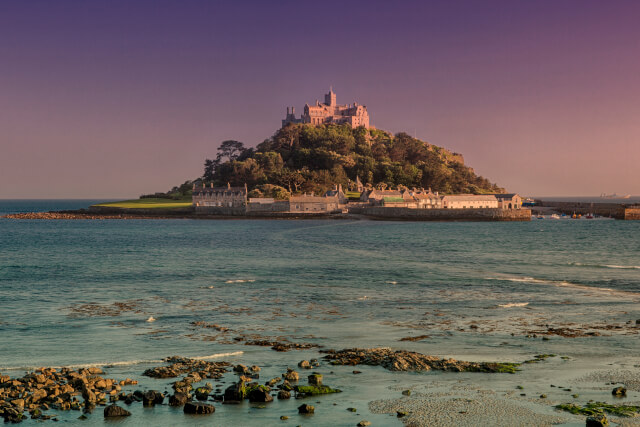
[324,348,516,372]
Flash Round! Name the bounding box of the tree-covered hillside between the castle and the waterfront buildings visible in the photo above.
[203,124,504,193]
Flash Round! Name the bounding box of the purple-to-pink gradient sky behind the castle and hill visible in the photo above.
[0,0,640,198]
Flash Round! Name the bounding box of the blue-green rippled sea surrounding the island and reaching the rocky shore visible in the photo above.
[0,200,640,426]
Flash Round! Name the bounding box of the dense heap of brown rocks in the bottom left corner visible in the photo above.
[0,368,137,423]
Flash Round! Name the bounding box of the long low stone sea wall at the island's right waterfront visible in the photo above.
[349,206,531,221]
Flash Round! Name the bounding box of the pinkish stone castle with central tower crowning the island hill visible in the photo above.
[282,89,369,129]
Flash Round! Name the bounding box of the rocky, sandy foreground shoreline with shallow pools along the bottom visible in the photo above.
[0,347,640,426]
